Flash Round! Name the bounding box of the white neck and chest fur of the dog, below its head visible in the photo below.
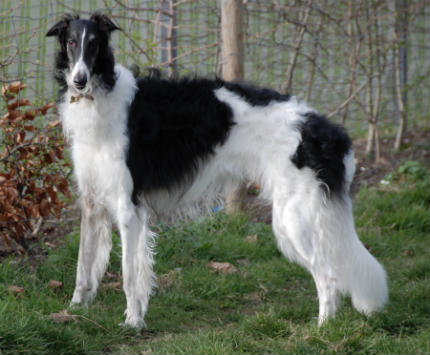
[59,65,136,213]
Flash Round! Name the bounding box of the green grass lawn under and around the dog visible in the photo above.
[0,171,430,354]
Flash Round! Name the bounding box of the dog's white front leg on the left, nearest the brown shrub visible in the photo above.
[71,196,112,306]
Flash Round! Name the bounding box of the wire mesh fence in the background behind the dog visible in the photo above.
[0,0,430,128]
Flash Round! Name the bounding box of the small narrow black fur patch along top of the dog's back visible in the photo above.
[224,82,290,106]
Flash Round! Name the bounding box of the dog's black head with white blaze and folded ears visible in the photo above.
[46,13,119,94]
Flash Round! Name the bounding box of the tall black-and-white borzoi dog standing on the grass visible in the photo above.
[47,13,387,327]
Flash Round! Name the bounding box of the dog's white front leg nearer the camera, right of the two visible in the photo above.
[118,202,155,328]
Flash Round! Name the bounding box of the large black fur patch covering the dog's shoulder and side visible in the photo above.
[127,77,234,203]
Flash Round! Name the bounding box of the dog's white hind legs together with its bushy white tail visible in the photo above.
[273,174,387,324]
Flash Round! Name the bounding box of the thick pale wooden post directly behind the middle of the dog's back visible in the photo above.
[221,0,246,213]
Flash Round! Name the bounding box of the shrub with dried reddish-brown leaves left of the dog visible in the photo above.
[0,82,70,252]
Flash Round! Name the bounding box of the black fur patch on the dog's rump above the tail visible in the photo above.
[291,112,351,194]
